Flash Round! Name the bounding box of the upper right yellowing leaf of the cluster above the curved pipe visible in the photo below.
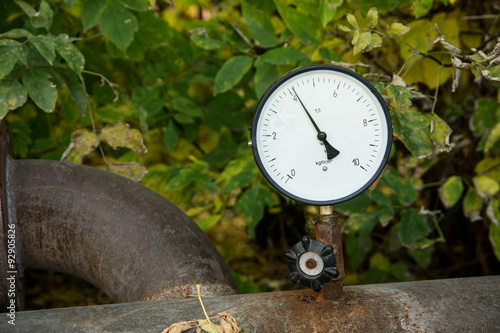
[99,121,147,154]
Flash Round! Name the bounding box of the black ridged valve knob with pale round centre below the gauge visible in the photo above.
[285,236,339,292]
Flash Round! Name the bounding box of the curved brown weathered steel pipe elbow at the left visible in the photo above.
[0,120,237,311]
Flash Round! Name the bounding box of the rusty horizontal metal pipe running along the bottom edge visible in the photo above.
[4,276,500,333]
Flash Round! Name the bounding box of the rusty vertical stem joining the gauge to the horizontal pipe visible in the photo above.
[315,206,345,299]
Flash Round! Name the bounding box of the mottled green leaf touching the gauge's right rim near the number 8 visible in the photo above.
[391,109,432,158]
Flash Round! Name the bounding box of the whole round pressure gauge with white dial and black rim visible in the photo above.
[251,65,392,205]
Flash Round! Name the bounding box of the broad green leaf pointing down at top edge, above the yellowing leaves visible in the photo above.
[100,2,138,50]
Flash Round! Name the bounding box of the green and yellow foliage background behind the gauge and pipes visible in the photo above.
[0,0,500,309]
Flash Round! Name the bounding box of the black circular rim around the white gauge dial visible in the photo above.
[251,65,392,206]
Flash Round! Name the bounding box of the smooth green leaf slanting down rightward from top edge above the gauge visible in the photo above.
[274,0,323,45]
